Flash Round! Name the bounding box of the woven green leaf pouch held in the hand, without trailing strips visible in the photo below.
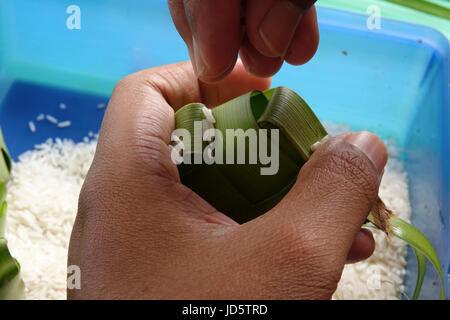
[175,87,327,223]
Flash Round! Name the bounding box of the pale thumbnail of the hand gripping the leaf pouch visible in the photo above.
[345,131,388,177]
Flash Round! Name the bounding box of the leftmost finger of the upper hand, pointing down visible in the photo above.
[169,0,242,83]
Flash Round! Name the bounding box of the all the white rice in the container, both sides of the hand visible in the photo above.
[6,123,411,299]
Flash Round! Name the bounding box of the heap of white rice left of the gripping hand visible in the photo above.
[6,139,97,299]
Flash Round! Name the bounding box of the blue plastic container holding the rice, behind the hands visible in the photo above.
[0,0,450,299]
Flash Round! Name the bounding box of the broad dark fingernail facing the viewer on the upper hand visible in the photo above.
[259,0,304,57]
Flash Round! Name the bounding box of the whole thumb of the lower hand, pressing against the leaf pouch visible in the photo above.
[241,132,387,292]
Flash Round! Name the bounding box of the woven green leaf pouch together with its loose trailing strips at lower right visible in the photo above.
[175,87,444,299]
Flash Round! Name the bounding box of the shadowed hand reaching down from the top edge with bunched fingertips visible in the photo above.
[169,0,319,82]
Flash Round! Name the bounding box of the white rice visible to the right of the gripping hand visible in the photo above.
[324,122,411,300]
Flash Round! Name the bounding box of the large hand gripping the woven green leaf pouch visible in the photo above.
[68,62,387,299]
